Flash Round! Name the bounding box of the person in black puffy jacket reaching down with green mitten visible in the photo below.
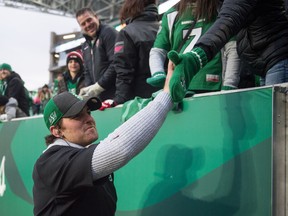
[168,0,288,101]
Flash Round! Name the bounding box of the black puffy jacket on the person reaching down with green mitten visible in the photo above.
[196,0,288,76]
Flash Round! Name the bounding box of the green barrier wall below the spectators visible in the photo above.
[0,87,273,216]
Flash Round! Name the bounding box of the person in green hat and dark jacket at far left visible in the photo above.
[0,63,29,116]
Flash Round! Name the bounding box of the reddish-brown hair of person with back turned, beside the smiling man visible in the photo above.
[119,0,156,22]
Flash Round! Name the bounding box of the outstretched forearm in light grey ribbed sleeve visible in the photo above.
[92,92,173,179]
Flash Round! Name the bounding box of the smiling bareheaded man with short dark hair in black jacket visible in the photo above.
[76,8,117,100]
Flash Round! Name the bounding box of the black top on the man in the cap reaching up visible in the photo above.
[33,145,117,216]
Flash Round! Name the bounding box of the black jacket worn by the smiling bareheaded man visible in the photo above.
[82,23,118,100]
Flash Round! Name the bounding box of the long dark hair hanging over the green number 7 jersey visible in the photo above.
[177,0,219,22]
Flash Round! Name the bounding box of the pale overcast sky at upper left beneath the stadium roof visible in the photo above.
[0,6,80,90]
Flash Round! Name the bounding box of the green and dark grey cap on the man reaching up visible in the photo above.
[44,92,101,129]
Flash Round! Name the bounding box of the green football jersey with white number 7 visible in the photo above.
[154,8,222,91]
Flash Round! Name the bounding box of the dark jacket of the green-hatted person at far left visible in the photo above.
[4,72,30,116]
